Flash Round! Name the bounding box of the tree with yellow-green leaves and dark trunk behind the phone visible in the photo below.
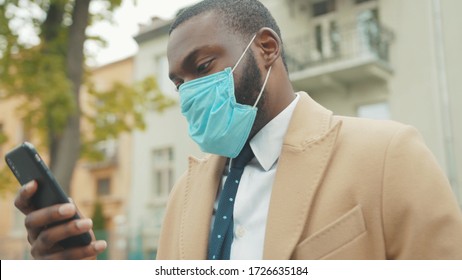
[0,0,172,192]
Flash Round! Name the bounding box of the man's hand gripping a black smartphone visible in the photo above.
[5,143,106,259]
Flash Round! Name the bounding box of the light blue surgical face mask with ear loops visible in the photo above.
[179,33,271,158]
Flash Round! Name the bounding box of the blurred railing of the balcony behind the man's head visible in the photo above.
[285,23,393,73]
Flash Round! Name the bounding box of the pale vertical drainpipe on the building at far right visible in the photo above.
[432,0,462,199]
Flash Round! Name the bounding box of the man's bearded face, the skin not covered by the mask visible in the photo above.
[167,12,265,136]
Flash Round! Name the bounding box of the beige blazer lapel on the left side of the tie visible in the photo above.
[180,156,226,260]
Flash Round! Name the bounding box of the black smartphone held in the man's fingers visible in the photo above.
[5,142,91,248]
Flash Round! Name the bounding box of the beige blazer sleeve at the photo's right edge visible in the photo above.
[382,126,462,259]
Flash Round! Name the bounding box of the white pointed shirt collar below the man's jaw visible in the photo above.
[250,94,300,171]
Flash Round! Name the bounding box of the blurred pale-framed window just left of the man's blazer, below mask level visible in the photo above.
[152,147,175,199]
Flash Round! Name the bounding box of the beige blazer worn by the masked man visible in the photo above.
[157,93,462,259]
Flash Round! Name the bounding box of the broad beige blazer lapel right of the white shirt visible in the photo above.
[263,93,341,259]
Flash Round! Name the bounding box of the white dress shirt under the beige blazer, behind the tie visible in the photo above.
[214,95,299,260]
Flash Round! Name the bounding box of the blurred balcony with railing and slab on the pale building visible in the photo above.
[285,23,393,91]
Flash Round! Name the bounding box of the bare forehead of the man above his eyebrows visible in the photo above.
[167,12,236,68]
